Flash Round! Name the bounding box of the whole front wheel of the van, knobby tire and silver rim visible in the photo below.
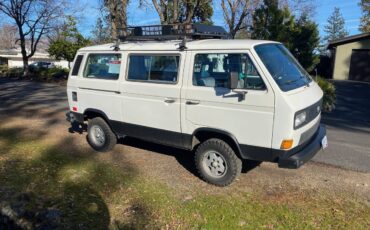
[195,139,242,186]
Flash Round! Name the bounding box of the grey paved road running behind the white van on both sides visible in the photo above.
[0,79,370,172]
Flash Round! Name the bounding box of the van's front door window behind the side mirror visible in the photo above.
[193,54,265,90]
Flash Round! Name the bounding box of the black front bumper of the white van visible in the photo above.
[278,125,326,169]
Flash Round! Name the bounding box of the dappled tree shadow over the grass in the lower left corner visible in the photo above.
[0,126,152,229]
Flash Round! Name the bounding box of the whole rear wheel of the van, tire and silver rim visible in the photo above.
[87,117,117,152]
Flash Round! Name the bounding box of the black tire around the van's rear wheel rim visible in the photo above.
[87,117,117,152]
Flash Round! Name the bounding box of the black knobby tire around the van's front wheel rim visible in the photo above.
[195,138,242,187]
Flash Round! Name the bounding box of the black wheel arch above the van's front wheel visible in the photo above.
[191,128,242,158]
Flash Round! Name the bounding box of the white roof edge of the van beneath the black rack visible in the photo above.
[80,39,276,52]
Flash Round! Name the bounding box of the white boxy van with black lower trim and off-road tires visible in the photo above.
[67,24,327,186]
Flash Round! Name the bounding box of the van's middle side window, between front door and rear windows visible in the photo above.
[127,54,180,83]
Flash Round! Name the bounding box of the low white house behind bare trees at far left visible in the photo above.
[0,49,68,68]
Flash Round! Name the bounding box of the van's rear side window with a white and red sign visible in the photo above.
[84,54,121,80]
